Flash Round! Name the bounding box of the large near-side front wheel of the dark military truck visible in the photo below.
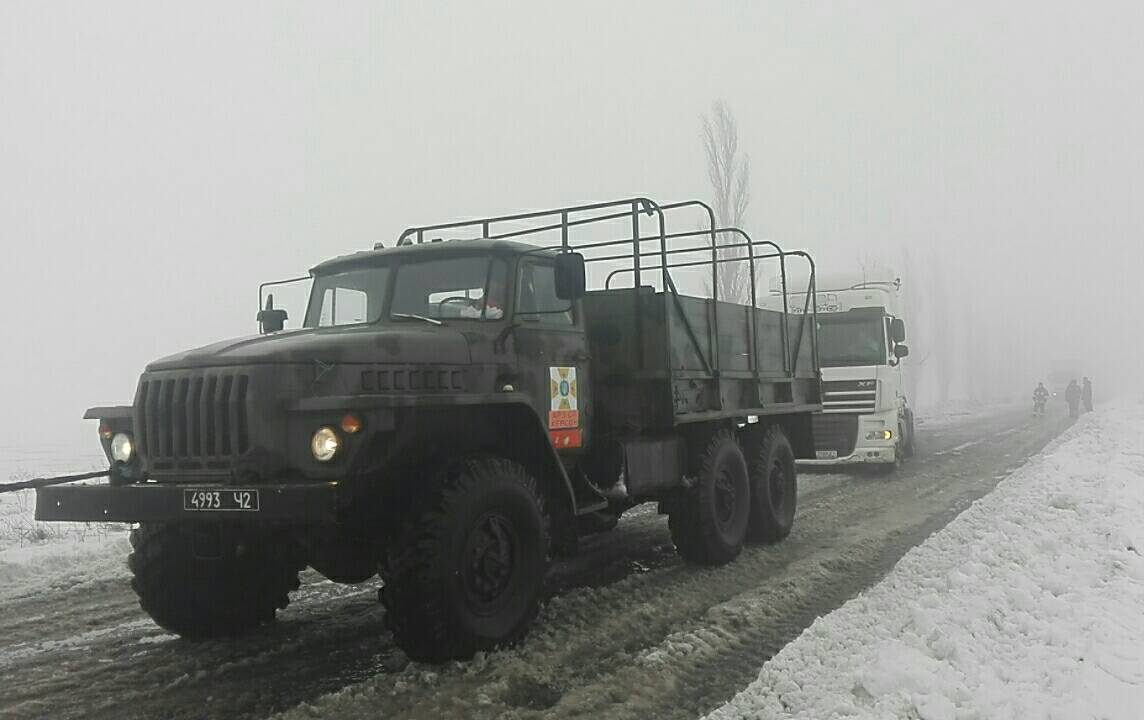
[382,459,549,660]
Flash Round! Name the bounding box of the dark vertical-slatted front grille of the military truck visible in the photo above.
[135,371,251,472]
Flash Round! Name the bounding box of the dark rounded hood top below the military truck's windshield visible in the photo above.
[148,325,471,370]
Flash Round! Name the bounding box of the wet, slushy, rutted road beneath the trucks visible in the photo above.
[0,407,1059,720]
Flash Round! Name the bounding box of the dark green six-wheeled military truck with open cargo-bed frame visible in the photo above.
[37,198,821,660]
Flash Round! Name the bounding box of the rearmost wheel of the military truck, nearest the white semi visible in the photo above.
[749,426,799,543]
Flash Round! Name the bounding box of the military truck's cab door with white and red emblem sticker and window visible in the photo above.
[515,256,591,453]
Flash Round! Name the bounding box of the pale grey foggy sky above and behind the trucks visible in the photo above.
[0,1,1144,440]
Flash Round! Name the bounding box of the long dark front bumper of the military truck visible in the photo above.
[35,482,337,525]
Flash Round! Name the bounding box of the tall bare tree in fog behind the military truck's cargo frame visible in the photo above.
[702,100,750,302]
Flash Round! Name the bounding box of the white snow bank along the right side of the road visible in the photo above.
[708,405,1144,720]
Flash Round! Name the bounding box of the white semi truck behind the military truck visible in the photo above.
[769,274,914,469]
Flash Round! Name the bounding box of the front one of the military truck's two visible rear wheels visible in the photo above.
[668,432,750,565]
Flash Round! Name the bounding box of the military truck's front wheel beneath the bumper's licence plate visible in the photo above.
[127,523,302,640]
